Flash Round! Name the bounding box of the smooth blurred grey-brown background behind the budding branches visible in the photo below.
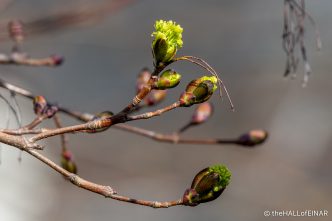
[0,0,332,221]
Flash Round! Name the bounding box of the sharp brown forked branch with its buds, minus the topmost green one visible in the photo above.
[0,18,267,208]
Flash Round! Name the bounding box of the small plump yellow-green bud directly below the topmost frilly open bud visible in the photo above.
[153,69,181,90]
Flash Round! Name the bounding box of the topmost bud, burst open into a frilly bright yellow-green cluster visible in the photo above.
[152,20,183,66]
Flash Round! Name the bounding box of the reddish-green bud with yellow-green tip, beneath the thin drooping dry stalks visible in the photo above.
[180,76,218,107]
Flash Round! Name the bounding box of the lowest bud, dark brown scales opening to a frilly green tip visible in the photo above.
[182,165,231,206]
